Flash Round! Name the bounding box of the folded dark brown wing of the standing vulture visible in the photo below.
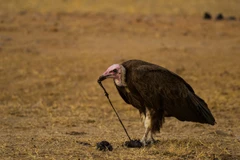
[128,64,215,124]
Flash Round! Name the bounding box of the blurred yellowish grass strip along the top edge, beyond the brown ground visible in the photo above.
[0,0,240,16]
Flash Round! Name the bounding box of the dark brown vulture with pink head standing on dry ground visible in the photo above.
[98,60,216,145]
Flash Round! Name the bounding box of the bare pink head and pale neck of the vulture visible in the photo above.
[98,64,125,85]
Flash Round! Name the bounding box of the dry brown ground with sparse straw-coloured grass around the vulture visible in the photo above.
[0,0,240,160]
